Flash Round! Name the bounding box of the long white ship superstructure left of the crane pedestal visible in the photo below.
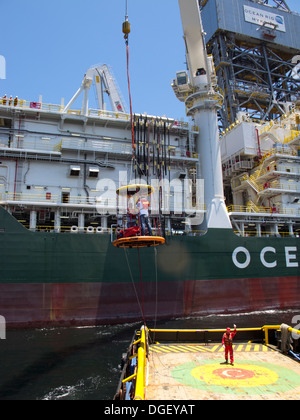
[0,71,204,234]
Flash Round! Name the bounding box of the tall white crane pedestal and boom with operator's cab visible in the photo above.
[172,0,232,229]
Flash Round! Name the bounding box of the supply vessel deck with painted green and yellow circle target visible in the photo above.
[114,324,300,404]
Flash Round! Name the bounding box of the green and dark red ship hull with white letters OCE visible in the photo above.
[0,208,300,328]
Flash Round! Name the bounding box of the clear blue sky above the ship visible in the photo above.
[0,0,300,118]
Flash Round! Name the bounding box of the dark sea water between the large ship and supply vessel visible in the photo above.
[0,309,300,400]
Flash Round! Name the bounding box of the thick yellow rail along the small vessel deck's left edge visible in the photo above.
[134,326,147,400]
